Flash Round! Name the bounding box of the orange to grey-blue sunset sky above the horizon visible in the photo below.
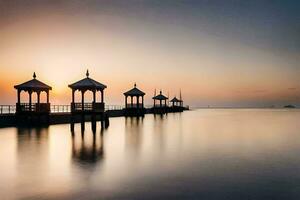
[0,0,300,107]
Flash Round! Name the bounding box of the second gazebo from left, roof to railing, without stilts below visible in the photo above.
[69,70,107,113]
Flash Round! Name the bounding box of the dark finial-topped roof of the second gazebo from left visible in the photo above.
[69,70,107,90]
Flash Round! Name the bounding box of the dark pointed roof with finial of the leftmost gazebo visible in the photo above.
[14,73,52,91]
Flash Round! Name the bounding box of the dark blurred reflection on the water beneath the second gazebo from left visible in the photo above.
[71,130,104,166]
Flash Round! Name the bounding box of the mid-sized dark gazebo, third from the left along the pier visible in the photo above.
[124,84,145,110]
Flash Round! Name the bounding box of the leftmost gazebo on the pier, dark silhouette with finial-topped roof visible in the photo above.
[14,73,52,114]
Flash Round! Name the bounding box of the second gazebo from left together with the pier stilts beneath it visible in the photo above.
[69,71,109,131]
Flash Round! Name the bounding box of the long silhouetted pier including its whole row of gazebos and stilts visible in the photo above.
[0,70,188,128]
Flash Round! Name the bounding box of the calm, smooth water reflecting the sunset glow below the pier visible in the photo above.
[0,109,300,200]
